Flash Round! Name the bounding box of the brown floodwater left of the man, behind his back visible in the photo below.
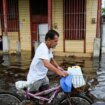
[0,53,31,91]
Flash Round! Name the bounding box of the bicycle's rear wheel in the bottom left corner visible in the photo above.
[0,92,22,105]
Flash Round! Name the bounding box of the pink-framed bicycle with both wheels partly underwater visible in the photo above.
[0,78,93,105]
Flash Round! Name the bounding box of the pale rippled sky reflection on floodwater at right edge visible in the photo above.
[91,54,105,101]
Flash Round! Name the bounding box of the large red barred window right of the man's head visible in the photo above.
[64,0,86,40]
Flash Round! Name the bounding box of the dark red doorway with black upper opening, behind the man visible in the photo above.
[30,0,48,53]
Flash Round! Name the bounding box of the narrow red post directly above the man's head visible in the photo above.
[48,0,52,29]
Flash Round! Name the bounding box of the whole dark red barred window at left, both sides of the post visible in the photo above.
[0,0,19,32]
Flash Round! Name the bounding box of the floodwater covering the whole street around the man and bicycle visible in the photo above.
[0,52,105,105]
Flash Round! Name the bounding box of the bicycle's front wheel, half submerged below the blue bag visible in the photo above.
[53,94,92,105]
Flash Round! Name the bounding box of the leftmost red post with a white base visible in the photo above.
[3,0,9,53]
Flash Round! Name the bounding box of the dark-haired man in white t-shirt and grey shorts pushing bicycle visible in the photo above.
[27,30,68,91]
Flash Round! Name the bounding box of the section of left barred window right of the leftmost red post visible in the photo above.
[7,0,19,31]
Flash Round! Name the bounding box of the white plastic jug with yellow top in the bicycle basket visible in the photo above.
[67,66,86,88]
